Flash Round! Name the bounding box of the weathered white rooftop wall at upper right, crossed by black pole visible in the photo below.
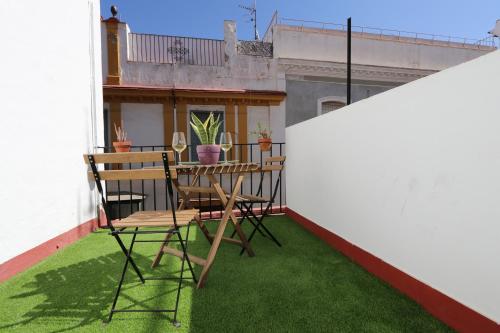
[273,25,493,70]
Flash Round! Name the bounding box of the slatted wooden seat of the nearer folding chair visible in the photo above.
[113,209,199,228]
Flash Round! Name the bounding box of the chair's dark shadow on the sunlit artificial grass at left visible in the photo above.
[0,252,183,332]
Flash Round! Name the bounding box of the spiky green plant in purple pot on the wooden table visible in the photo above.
[190,112,221,165]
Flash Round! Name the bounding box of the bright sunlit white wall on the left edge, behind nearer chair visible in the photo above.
[0,0,103,263]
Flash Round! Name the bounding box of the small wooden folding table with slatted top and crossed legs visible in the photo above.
[152,163,259,288]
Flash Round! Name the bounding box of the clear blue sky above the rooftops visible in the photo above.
[101,0,500,39]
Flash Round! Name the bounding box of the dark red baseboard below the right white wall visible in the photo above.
[286,208,500,333]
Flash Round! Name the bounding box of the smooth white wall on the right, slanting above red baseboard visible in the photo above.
[286,51,500,322]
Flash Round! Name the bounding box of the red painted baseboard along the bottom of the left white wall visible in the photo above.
[0,218,97,283]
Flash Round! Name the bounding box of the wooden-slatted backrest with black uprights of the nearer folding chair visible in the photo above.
[83,151,177,226]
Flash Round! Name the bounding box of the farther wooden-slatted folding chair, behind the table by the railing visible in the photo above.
[231,156,286,254]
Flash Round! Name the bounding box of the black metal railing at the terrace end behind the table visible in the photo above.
[97,142,286,223]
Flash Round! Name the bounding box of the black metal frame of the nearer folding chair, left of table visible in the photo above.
[88,152,197,327]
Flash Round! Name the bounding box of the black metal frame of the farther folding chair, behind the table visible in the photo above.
[231,157,284,255]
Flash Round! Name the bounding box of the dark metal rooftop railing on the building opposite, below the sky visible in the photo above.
[128,33,225,66]
